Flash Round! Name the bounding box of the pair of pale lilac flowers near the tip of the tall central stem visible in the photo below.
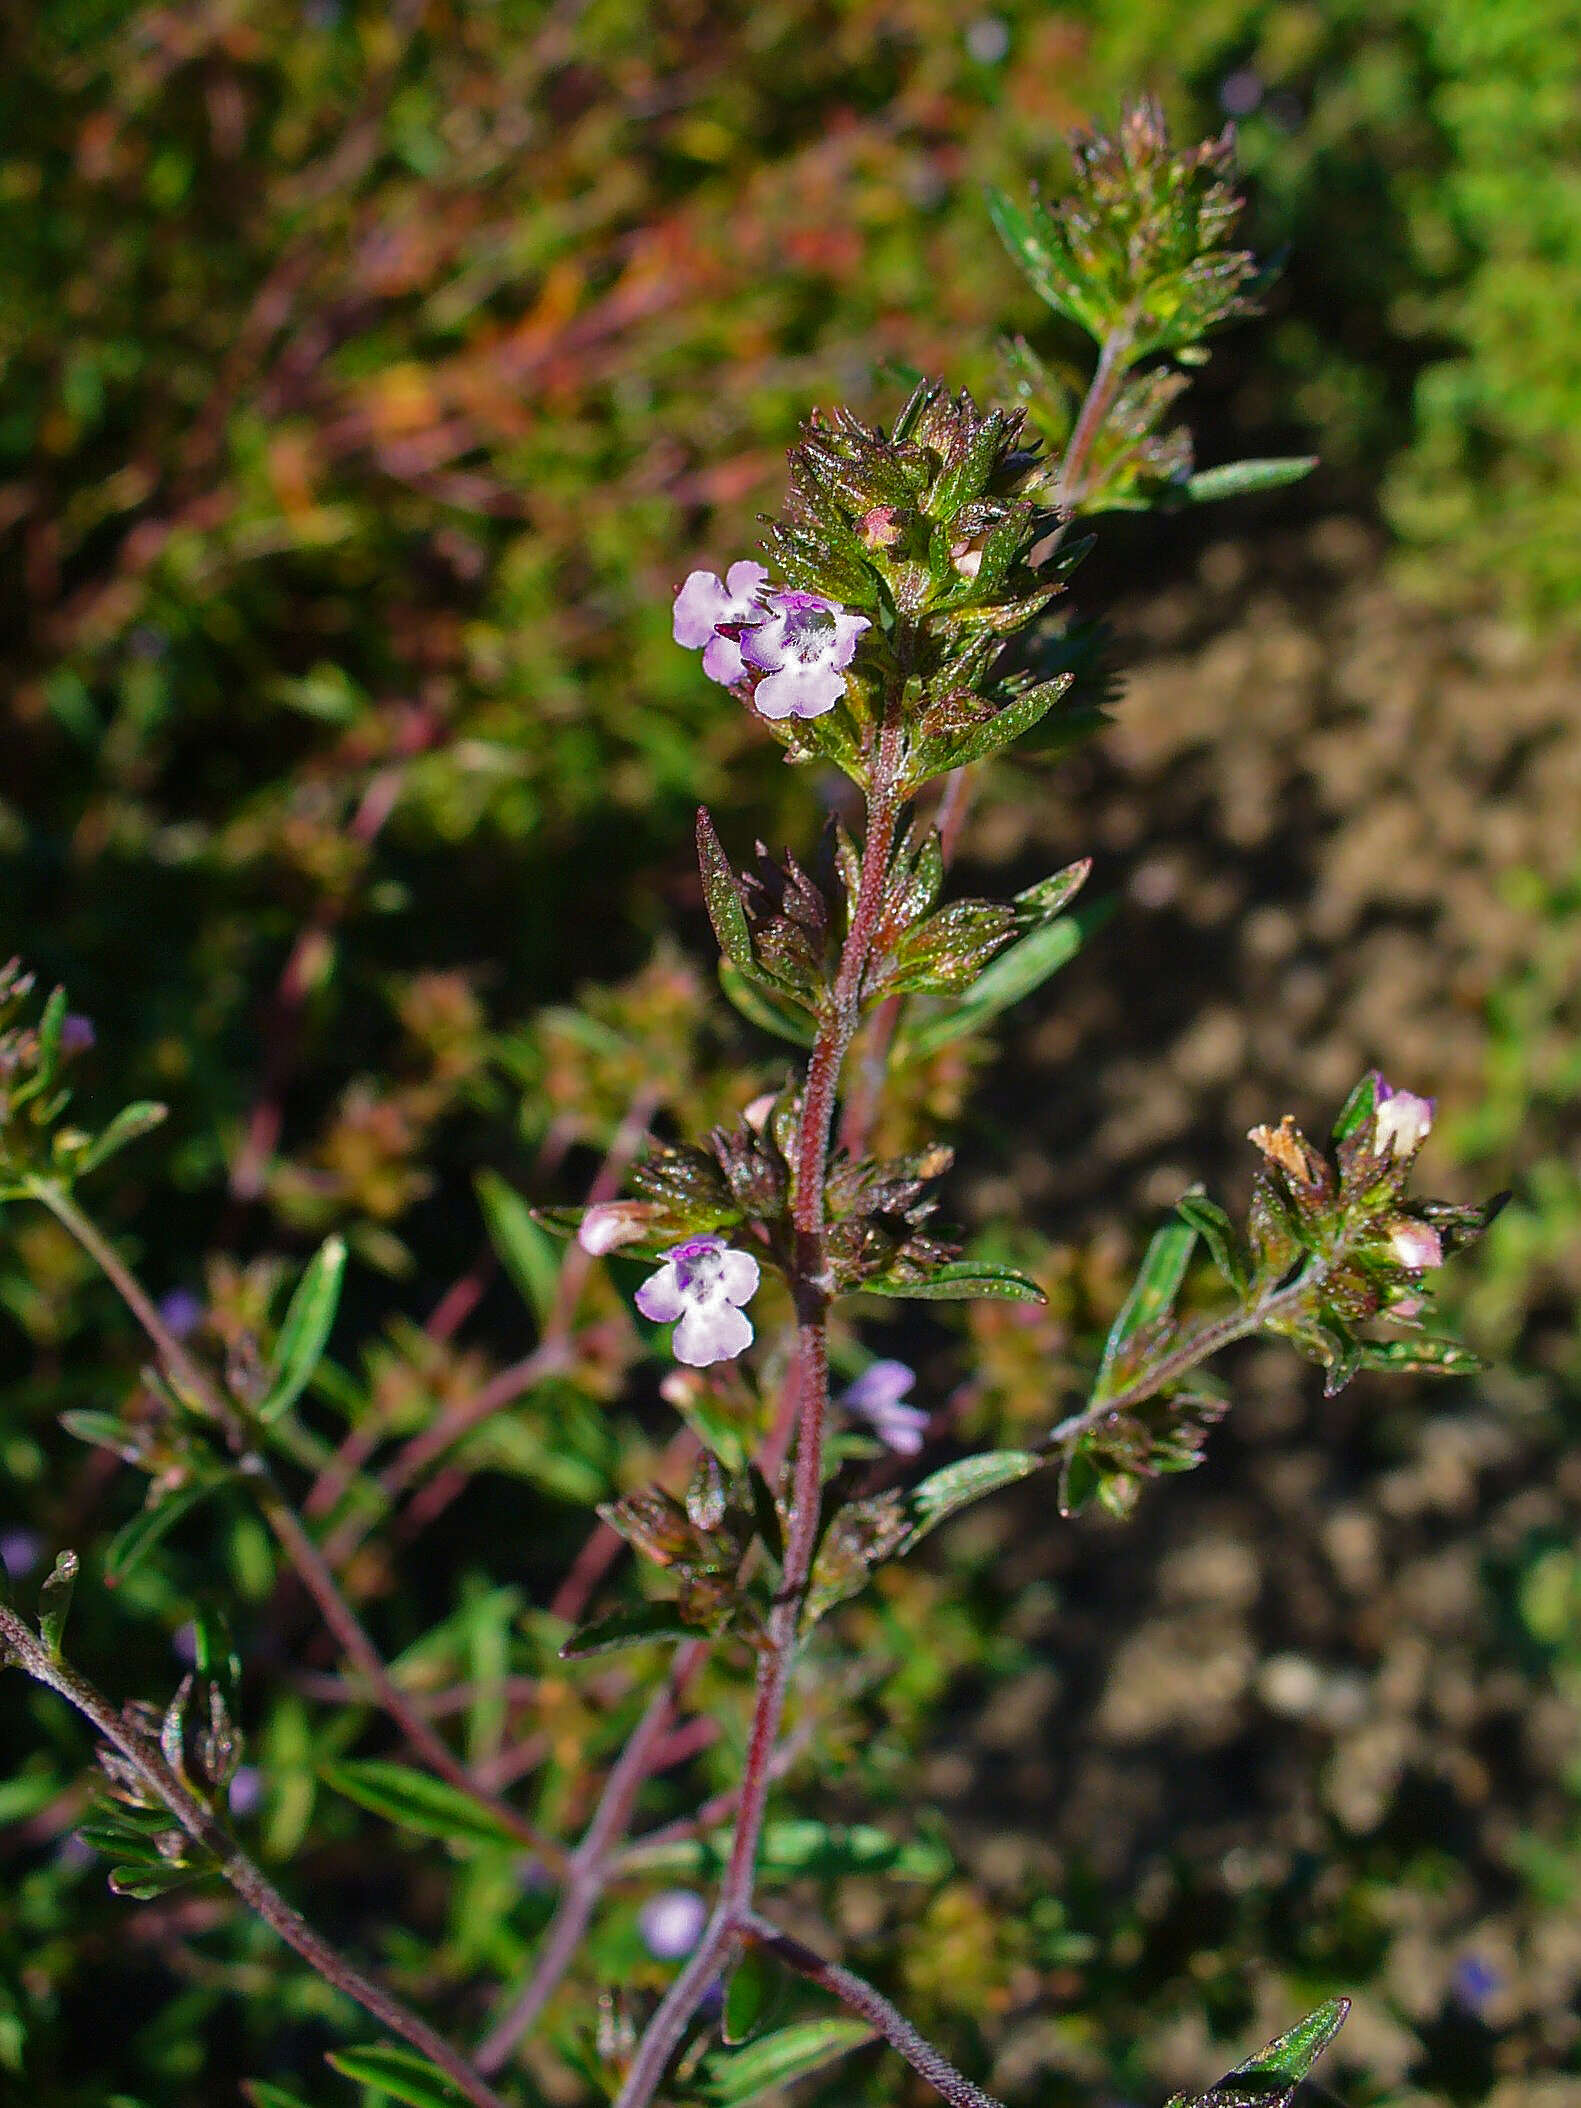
[675,559,873,719]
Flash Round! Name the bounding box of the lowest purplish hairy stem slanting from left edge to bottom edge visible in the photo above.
[0,1606,504,2108]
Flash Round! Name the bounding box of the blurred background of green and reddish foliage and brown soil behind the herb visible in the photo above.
[0,0,1581,2108]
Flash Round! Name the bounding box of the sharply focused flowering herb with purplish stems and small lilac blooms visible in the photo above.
[0,103,1490,2108]
